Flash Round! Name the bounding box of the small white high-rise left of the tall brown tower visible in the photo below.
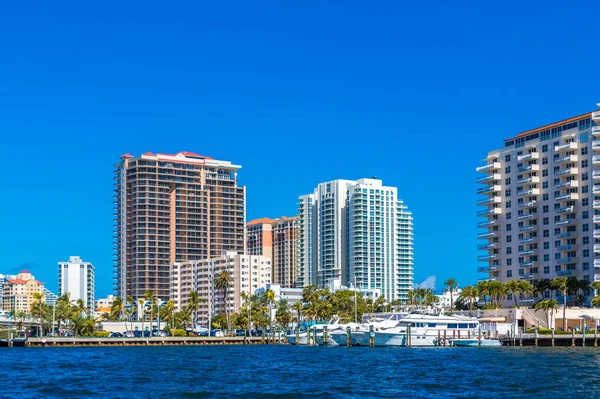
[58,256,96,312]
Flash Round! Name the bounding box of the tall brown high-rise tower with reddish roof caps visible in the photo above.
[114,152,246,299]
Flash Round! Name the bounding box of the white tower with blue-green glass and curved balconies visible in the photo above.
[296,179,413,300]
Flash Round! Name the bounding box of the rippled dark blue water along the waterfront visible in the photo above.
[0,345,600,399]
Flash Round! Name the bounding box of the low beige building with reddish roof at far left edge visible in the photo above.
[2,270,45,313]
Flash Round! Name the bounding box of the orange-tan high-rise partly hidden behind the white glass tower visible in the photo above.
[246,216,296,288]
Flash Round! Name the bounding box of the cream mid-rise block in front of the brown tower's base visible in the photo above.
[170,251,271,325]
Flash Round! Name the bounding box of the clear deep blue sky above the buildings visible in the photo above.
[0,1,600,297]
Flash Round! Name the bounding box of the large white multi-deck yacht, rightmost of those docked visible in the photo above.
[366,313,479,346]
